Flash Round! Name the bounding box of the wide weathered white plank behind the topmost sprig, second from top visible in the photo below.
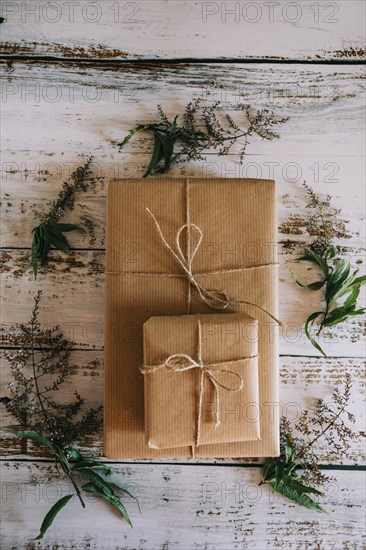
[2,63,365,248]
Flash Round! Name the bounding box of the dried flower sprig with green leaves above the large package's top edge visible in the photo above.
[118,98,288,177]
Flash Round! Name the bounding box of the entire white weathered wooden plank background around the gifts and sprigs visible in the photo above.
[0,0,365,550]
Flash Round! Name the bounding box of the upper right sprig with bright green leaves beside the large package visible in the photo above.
[293,184,366,356]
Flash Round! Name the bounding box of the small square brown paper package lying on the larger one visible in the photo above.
[141,313,260,449]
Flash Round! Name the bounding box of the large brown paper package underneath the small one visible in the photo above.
[104,178,279,459]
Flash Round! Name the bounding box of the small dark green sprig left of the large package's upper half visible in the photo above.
[31,157,92,278]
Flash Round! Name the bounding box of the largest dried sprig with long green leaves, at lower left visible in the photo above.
[1,291,135,539]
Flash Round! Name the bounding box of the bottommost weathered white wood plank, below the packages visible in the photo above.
[2,462,365,550]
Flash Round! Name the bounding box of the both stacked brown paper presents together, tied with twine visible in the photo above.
[104,178,279,458]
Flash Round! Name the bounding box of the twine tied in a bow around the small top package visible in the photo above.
[140,319,257,445]
